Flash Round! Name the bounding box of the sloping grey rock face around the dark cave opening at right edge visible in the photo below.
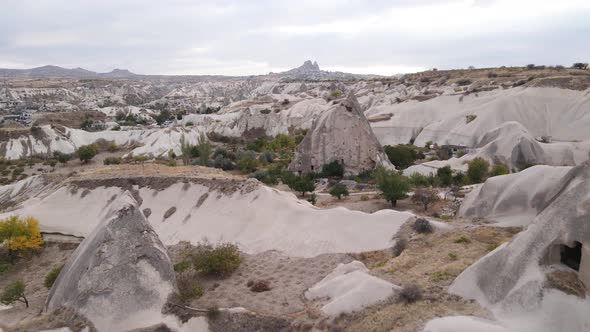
[450,162,590,308]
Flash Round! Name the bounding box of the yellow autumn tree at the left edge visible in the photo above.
[0,215,43,260]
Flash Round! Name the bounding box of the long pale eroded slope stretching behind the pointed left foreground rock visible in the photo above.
[0,178,413,257]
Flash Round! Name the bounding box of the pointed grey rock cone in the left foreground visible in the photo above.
[47,192,175,331]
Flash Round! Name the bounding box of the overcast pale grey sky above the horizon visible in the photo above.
[0,0,590,75]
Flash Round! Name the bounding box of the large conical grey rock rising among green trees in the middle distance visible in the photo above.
[289,92,393,174]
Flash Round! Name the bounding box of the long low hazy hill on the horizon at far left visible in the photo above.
[0,65,137,78]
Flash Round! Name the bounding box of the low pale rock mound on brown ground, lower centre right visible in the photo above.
[305,261,400,317]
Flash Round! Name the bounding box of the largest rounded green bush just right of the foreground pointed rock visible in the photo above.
[191,242,241,277]
